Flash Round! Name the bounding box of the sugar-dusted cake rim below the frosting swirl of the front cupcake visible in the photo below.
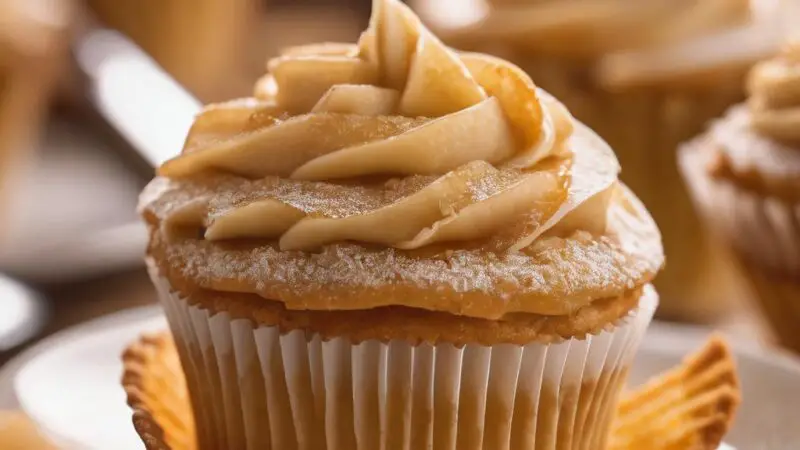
[151,187,660,319]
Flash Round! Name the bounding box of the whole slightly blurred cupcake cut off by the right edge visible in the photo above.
[681,42,800,351]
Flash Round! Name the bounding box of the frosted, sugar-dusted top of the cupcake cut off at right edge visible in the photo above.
[711,42,800,200]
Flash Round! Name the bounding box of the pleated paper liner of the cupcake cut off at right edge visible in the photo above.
[680,142,800,351]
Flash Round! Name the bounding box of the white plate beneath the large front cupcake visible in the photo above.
[0,307,800,450]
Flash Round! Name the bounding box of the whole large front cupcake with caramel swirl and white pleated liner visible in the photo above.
[140,0,663,450]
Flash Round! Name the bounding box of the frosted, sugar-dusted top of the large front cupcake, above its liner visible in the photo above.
[140,0,663,319]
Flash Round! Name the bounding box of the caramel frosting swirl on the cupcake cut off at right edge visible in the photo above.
[748,41,800,144]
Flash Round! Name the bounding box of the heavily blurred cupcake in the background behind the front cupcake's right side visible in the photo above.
[416,0,778,321]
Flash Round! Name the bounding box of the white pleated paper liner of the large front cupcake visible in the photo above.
[150,265,658,450]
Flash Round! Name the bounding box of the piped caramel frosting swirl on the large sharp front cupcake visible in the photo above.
[152,0,619,251]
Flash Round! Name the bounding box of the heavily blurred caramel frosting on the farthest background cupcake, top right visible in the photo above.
[429,0,751,56]
